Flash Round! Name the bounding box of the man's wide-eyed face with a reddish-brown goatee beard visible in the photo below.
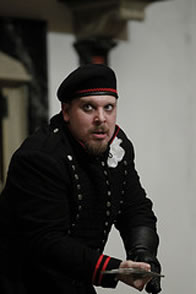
[62,95,117,155]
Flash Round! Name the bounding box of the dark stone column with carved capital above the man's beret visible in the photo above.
[60,0,165,64]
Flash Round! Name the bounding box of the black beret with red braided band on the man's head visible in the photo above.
[57,64,118,102]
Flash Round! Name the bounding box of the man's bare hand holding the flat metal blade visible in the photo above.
[117,260,151,291]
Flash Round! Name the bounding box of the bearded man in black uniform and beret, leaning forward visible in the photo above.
[0,65,161,294]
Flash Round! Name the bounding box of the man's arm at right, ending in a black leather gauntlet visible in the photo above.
[116,135,161,294]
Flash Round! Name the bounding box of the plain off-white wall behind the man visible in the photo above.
[48,0,196,294]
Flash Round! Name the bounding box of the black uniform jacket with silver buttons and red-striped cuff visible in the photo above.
[0,114,156,294]
